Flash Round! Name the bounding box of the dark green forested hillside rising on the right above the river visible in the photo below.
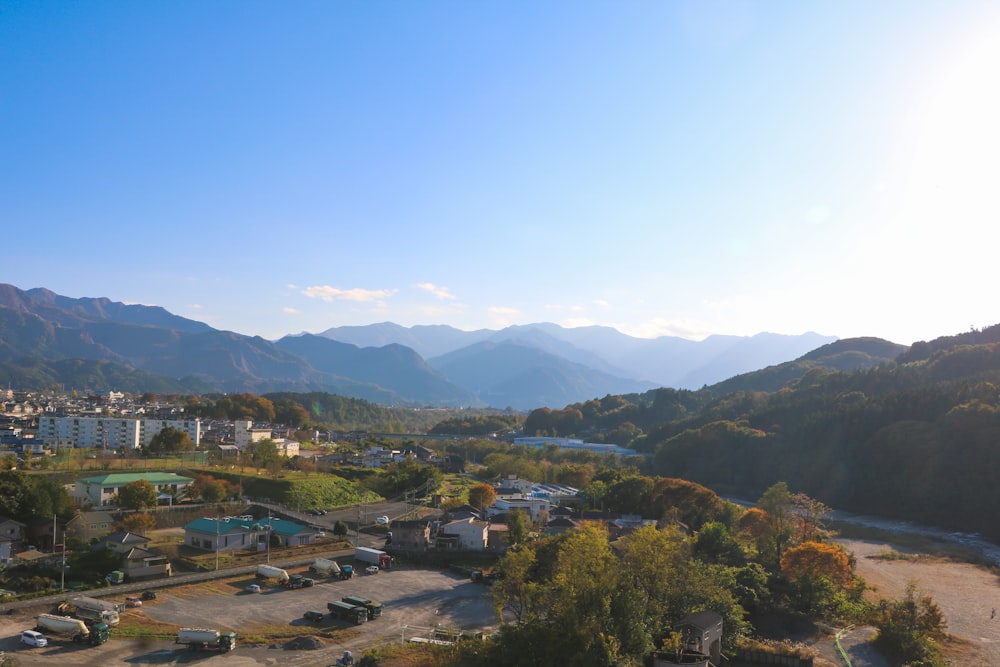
[525,327,1000,538]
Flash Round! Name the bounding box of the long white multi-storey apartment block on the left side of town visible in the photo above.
[38,417,201,450]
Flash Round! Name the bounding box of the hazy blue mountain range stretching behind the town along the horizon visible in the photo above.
[0,284,868,410]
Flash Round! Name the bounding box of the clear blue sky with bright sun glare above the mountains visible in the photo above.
[0,0,1000,343]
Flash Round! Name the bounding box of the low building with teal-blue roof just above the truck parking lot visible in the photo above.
[184,516,316,551]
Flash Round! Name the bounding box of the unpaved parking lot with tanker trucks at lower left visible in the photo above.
[0,568,495,667]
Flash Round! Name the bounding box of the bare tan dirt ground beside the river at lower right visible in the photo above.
[838,539,1000,667]
